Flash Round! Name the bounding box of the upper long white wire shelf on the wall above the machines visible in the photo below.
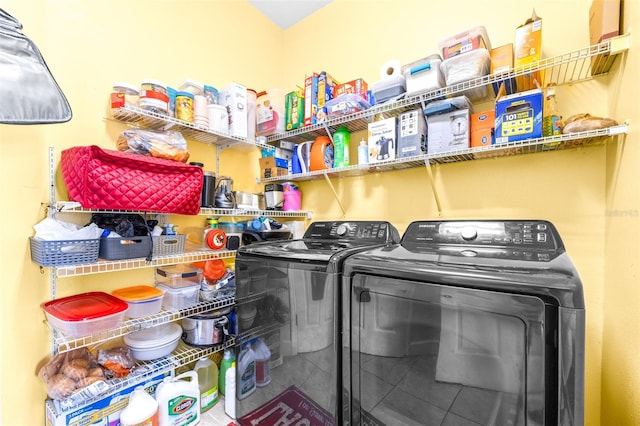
[265,34,630,145]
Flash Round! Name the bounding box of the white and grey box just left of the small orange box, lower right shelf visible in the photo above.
[427,109,470,154]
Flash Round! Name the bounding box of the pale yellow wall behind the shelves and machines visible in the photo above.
[0,0,640,426]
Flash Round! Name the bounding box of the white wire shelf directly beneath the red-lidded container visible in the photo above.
[52,298,235,353]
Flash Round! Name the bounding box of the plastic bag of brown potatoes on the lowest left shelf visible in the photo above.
[38,348,109,405]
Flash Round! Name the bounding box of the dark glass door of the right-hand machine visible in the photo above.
[344,274,554,426]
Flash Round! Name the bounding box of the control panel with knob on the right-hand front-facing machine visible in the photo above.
[402,220,564,251]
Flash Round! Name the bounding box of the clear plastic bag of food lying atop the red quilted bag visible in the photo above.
[116,129,189,163]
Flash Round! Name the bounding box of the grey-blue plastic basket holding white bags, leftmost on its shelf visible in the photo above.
[29,237,100,266]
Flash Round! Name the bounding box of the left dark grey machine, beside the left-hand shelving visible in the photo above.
[235,221,400,424]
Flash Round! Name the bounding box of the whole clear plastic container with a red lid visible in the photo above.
[41,291,129,337]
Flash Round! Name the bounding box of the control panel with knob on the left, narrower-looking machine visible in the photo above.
[303,221,400,244]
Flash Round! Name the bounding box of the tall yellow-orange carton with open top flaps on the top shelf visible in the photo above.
[514,11,543,91]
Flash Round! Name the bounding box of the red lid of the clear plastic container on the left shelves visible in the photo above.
[42,291,129,322]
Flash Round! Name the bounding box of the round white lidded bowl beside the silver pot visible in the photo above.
[124,322,182,361]
